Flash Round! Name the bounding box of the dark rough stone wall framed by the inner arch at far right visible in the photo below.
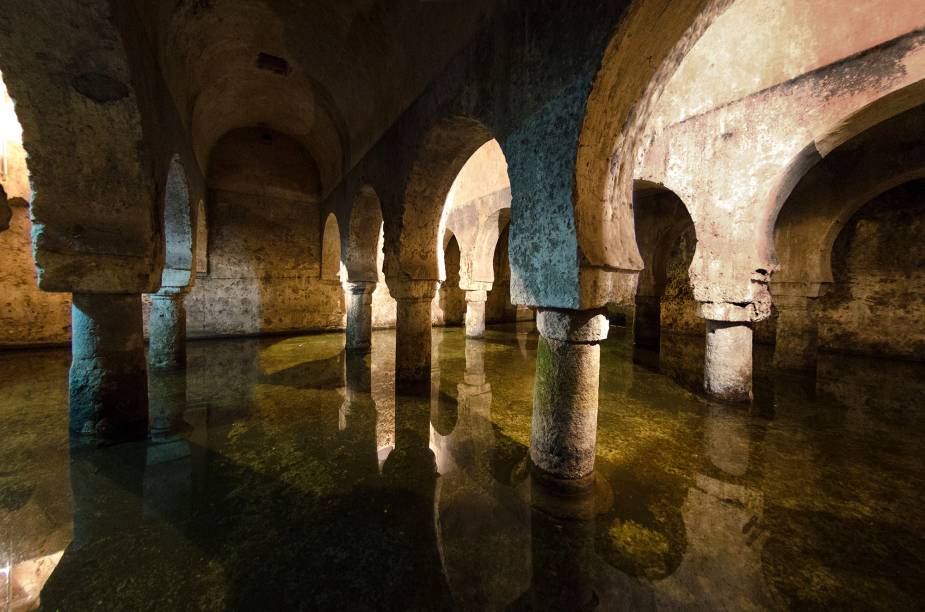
[817,180,925,360]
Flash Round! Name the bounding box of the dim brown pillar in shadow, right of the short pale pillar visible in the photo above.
[774,296,819,370]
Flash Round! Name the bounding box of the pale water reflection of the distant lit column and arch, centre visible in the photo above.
[433,338,530,610]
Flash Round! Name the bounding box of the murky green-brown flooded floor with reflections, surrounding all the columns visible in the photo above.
[0,325,925,610]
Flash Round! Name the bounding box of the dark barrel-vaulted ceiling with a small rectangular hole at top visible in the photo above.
[136,0,492,193]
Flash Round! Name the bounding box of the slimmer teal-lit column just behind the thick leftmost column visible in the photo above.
[148,287,189,369]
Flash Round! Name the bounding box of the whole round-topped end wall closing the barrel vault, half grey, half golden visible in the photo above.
[186,127,332,337]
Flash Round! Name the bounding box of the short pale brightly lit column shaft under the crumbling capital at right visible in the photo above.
[703,319,752,402]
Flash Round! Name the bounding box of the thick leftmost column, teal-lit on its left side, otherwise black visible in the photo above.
[68,293,148,439]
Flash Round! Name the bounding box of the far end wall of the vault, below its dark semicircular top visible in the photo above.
[186,191,344,337]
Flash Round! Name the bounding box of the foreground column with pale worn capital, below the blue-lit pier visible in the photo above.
[530,309,609,479]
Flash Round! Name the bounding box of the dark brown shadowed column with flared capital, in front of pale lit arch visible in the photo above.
[392,280,437,383]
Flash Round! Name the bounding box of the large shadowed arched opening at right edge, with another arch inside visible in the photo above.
[771,101,925,370]
